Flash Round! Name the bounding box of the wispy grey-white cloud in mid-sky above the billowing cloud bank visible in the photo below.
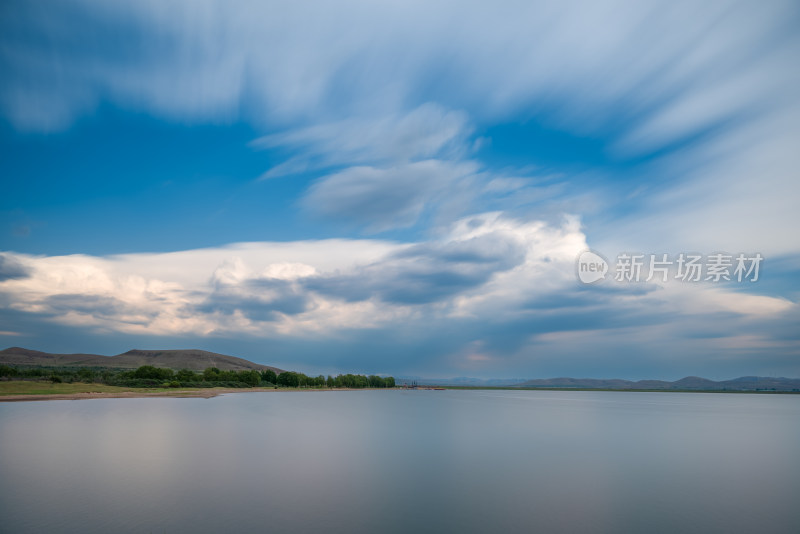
[252,103,479,233]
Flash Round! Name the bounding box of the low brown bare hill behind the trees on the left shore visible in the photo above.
[0,347,283,373]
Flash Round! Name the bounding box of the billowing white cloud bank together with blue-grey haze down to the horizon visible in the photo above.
[0,212,800,378]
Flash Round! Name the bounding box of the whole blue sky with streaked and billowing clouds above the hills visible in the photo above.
[0,0,800,380]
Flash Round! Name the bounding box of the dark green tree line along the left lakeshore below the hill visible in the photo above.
[0,365,395,389]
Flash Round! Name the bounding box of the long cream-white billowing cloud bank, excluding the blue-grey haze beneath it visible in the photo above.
[0,212,797,347]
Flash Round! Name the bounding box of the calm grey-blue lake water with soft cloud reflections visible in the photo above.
[0,391,800,533]
